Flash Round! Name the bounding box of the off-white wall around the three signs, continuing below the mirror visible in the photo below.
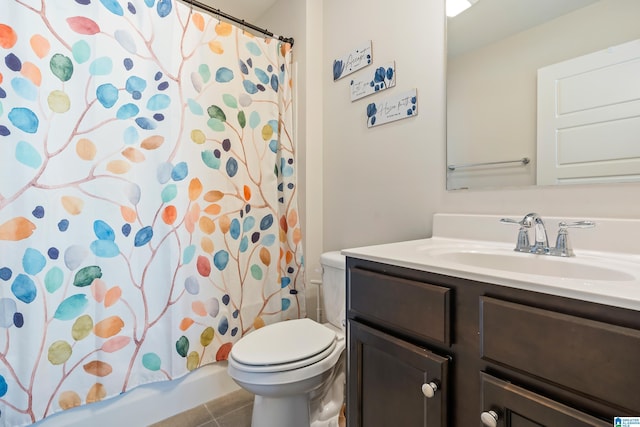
[322,0,640,250]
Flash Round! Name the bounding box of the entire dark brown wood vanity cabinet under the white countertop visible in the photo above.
[347,257,640,427]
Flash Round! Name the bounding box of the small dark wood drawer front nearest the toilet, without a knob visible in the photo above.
[347,268,451,346]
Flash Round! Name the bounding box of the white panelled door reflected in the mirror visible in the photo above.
[537,40,640,185]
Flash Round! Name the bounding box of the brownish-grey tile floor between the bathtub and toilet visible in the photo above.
[150,389,253,427]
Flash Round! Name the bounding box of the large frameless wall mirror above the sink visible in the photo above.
[446,0,640,190]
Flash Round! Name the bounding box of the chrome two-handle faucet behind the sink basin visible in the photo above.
[500,212,596,257]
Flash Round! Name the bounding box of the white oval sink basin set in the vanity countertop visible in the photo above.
[428,248,636,281]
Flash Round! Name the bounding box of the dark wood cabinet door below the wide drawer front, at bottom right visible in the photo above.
[480,373,612,427]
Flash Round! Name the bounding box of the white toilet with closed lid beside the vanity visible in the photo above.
[227,251,346,427]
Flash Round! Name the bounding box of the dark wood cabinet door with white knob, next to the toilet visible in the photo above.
[347,320,448,427]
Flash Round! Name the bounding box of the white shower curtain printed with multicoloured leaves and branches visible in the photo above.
[0,0,305,426]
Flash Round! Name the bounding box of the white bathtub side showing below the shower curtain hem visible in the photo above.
[33,362,239,427]
